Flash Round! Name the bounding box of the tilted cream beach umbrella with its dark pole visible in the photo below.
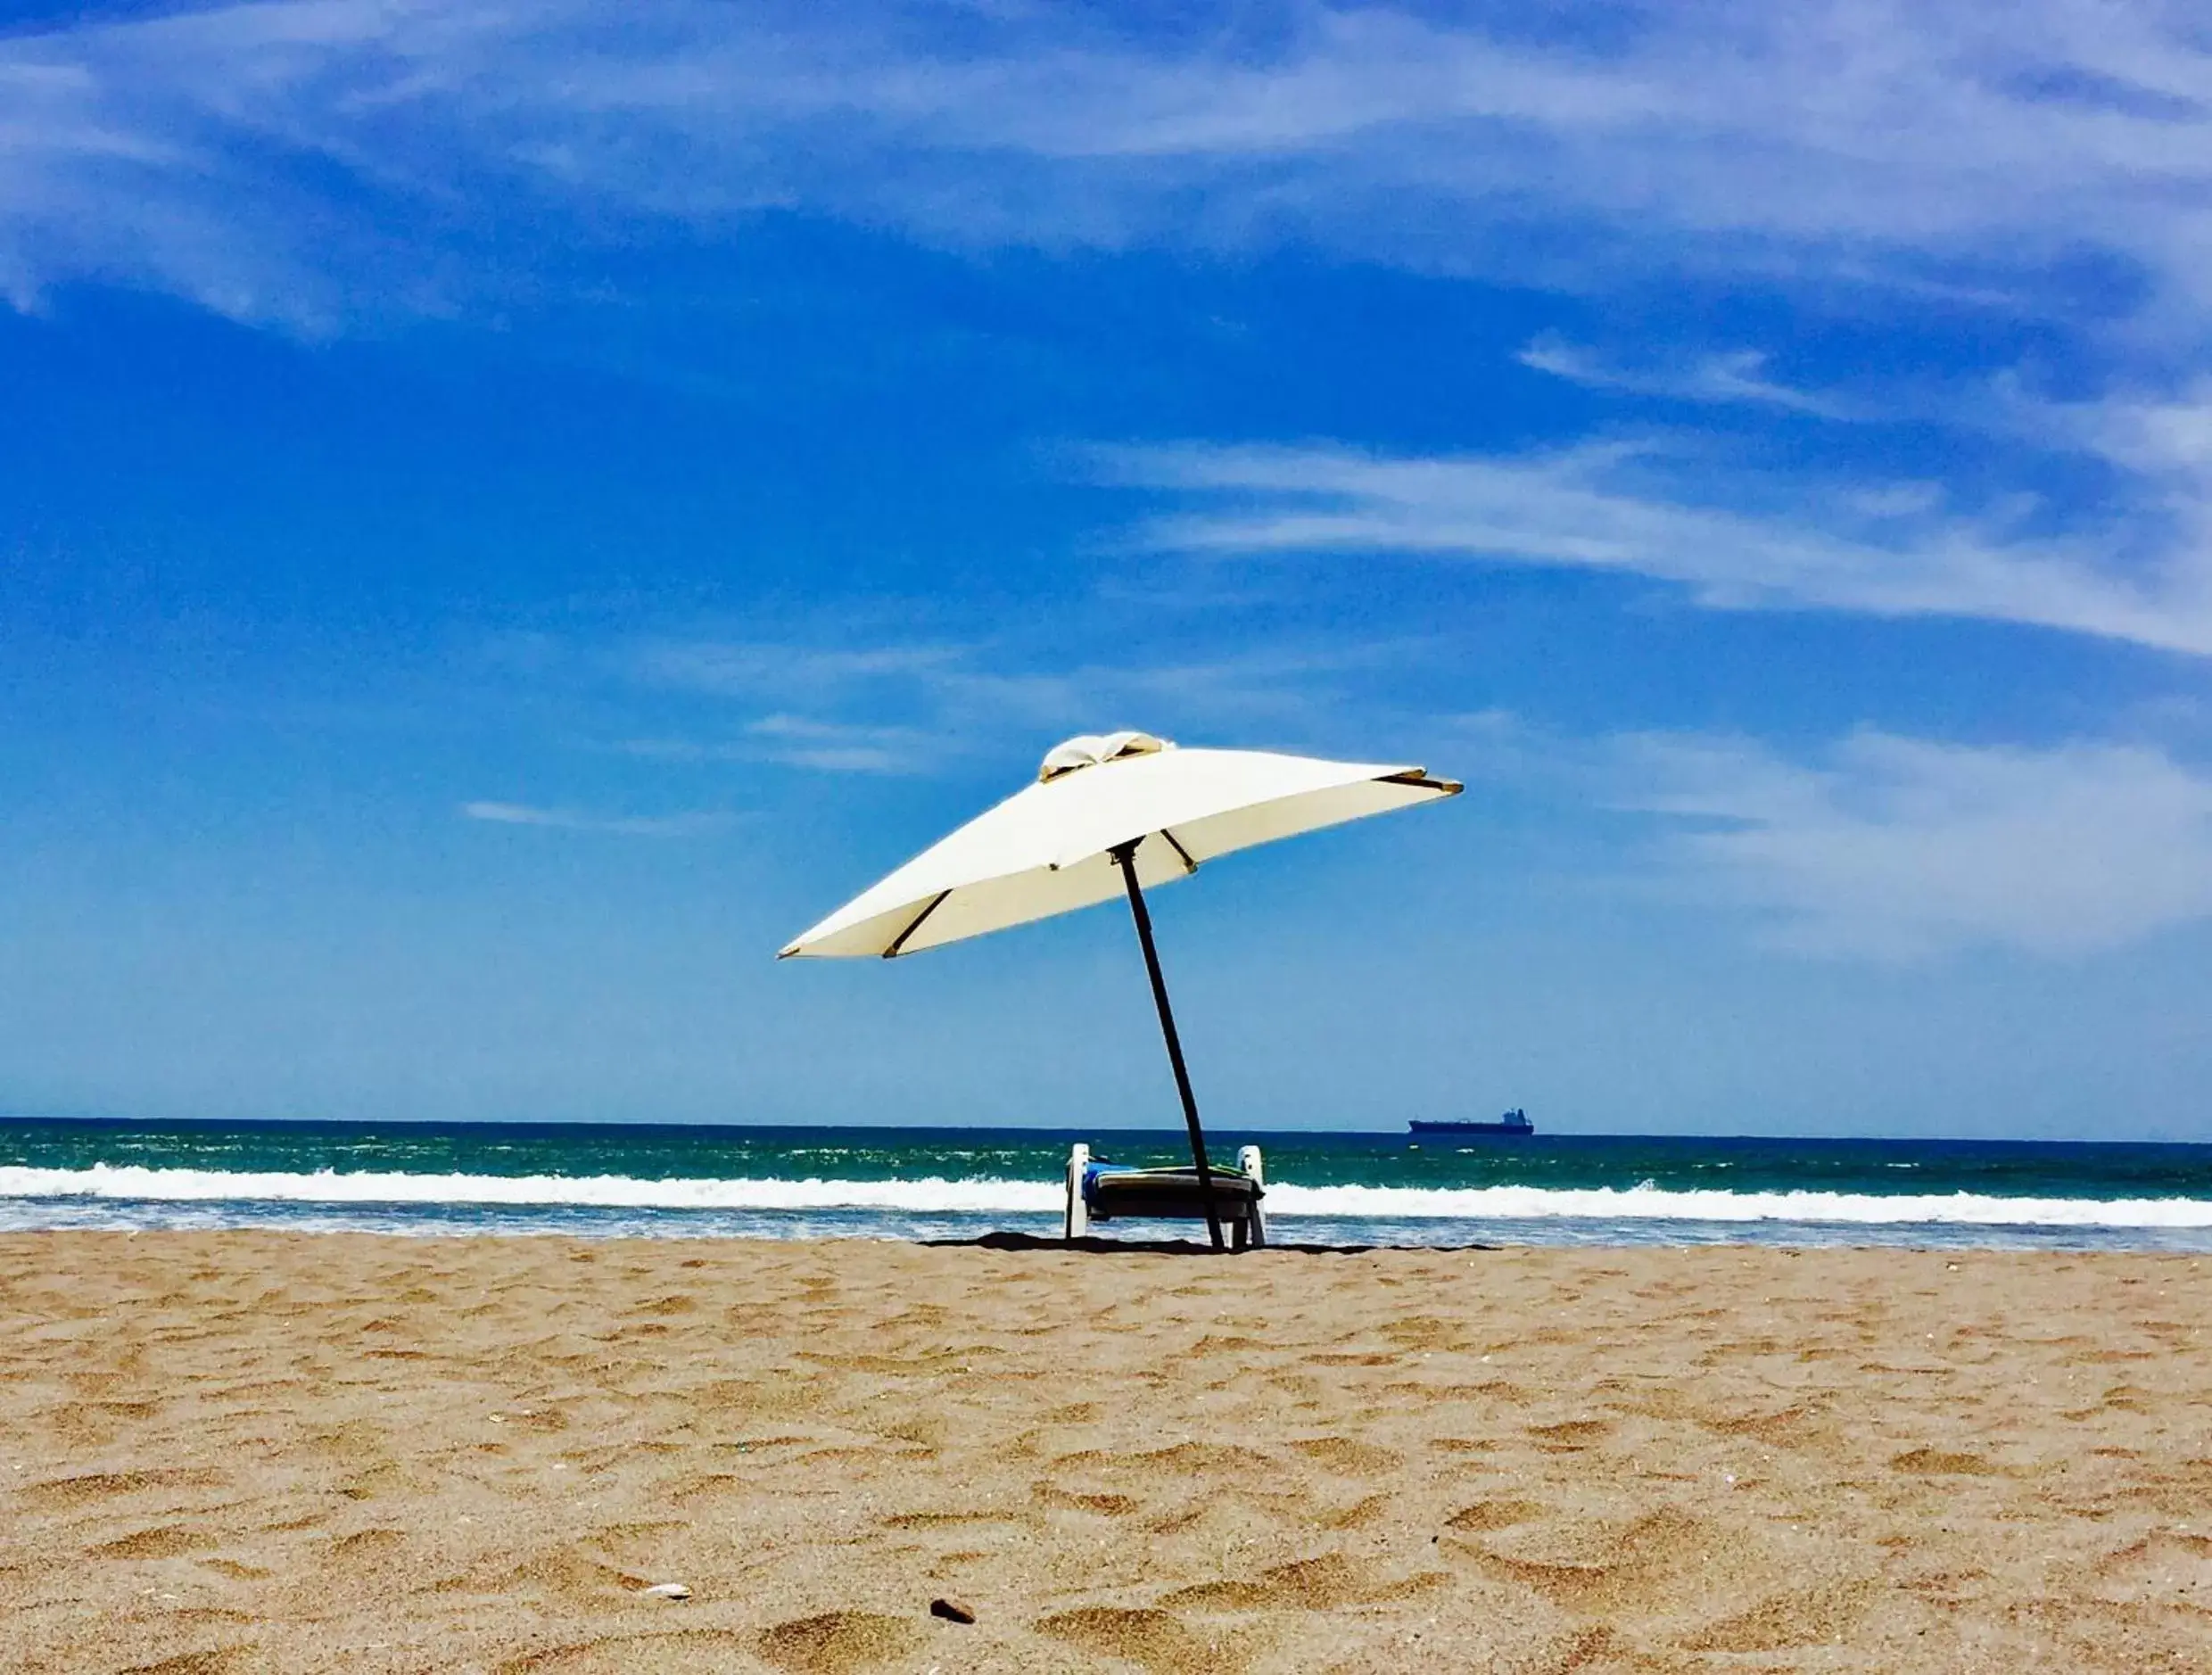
[776,732,1460,1248]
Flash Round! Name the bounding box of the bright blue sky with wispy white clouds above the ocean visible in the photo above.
[0,0,2212,1140]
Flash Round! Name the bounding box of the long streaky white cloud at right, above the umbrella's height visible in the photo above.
[1097,438,2212,655]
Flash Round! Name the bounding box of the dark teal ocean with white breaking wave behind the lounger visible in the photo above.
[0,1119,2212,1250]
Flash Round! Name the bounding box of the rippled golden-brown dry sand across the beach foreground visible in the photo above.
[0,1233,2212,1675]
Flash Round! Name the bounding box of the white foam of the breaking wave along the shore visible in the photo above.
[0,1164,2212,1228]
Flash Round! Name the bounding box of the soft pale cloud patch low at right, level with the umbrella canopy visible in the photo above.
[1617,732,2212,958]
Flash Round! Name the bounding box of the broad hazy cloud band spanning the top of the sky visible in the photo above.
[12,0,2212,330]
